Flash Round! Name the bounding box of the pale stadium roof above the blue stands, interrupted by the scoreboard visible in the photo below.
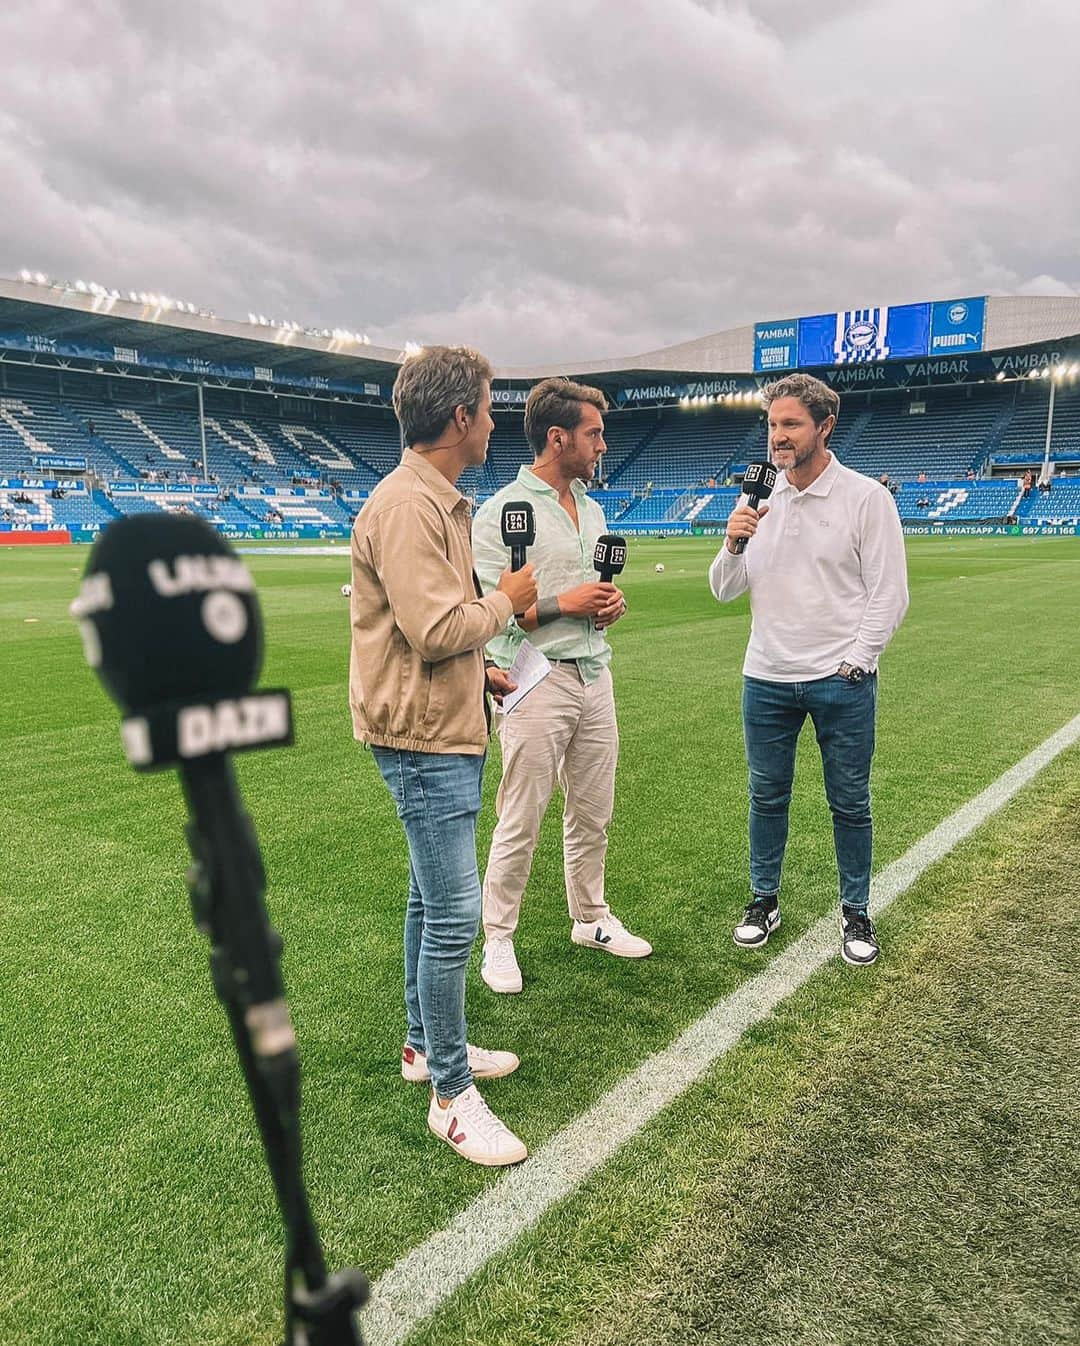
[0,279,1080,388]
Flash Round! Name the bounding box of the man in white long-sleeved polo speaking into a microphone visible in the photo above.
[708,374,908,965]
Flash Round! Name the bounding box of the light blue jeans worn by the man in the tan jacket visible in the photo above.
[372,746,483,1098]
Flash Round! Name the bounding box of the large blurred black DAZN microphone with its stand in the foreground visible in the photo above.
[71,513,368,1346]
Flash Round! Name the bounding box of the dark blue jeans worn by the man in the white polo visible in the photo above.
[742,673,878,910]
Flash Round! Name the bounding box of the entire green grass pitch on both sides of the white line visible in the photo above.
[0,538,1080,1346]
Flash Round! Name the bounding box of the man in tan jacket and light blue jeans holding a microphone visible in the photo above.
[349,346,536,1164]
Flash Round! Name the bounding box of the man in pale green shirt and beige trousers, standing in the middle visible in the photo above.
[473,378,652,993]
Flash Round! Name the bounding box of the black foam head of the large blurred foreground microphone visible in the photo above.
[71,510,263,715]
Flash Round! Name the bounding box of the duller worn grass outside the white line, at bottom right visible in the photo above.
[411,750,1080,1346]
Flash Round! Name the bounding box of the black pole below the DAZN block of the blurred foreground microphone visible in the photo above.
[180,752,369,1346]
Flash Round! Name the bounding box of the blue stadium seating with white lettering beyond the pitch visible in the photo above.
[0,370,1080,534]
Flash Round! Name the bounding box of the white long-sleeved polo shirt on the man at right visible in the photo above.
[708,455,908,682]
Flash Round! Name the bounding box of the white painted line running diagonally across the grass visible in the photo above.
[362,715,1080,1346]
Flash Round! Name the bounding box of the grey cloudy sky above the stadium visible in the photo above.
[0,0,1080,365]
